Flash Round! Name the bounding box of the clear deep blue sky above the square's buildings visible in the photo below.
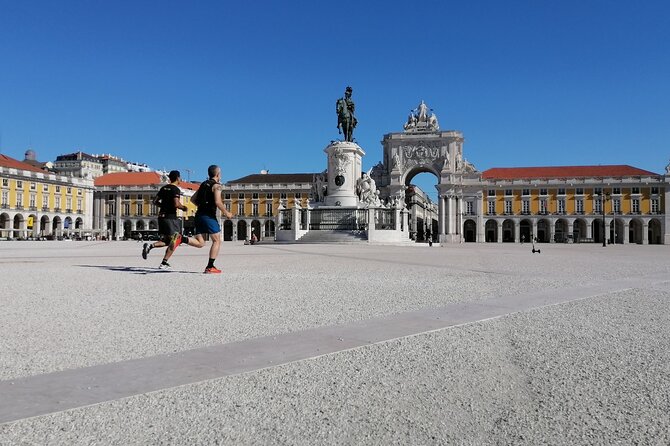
[0,0,670,198]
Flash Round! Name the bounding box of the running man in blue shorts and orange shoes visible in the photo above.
[191,164,233,274]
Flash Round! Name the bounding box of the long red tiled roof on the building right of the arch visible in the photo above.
[482,165,658,180]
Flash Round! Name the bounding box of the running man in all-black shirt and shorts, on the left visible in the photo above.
[142,170,205,269]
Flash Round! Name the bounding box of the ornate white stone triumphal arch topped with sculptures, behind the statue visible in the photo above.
[371,101,483,243]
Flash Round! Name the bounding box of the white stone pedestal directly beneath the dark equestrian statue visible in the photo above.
[324,141,365,207]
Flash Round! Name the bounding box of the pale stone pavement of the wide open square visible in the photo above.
[0,242,670,444]
